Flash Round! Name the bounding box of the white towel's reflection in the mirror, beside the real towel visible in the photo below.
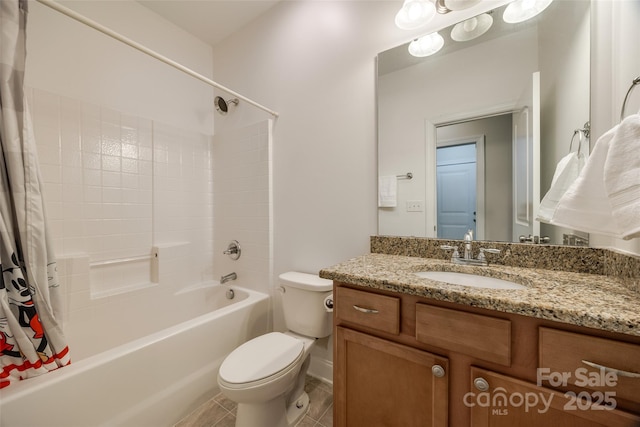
[537,151,587,222]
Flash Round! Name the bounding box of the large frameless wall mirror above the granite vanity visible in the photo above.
[377,0,590,244]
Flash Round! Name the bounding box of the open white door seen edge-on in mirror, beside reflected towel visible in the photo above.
[512,72,540,242]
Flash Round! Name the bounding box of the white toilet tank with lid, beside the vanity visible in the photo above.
[280,271,333,338]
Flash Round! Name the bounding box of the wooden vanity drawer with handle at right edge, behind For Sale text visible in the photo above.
[539,328,640,403]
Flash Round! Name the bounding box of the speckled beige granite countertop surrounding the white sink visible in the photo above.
[320,253,640,336]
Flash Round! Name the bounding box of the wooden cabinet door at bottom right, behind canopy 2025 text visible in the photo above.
[464,367,640,427]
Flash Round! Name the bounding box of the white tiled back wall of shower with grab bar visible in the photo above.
[28,89,214,352]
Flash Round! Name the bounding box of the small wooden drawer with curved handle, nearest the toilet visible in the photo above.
[334,287,400,335]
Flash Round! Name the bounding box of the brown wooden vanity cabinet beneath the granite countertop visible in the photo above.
[334,282,640,427]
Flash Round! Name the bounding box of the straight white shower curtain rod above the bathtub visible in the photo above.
[37,0,279,117]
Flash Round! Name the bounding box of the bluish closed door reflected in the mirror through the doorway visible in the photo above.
[436,144,477,239]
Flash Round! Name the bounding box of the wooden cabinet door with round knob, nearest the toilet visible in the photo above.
[334,327,449,427]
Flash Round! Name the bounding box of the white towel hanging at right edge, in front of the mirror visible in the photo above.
[551,115,640,239]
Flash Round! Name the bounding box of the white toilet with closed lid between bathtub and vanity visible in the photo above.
[218,272,333,427]
